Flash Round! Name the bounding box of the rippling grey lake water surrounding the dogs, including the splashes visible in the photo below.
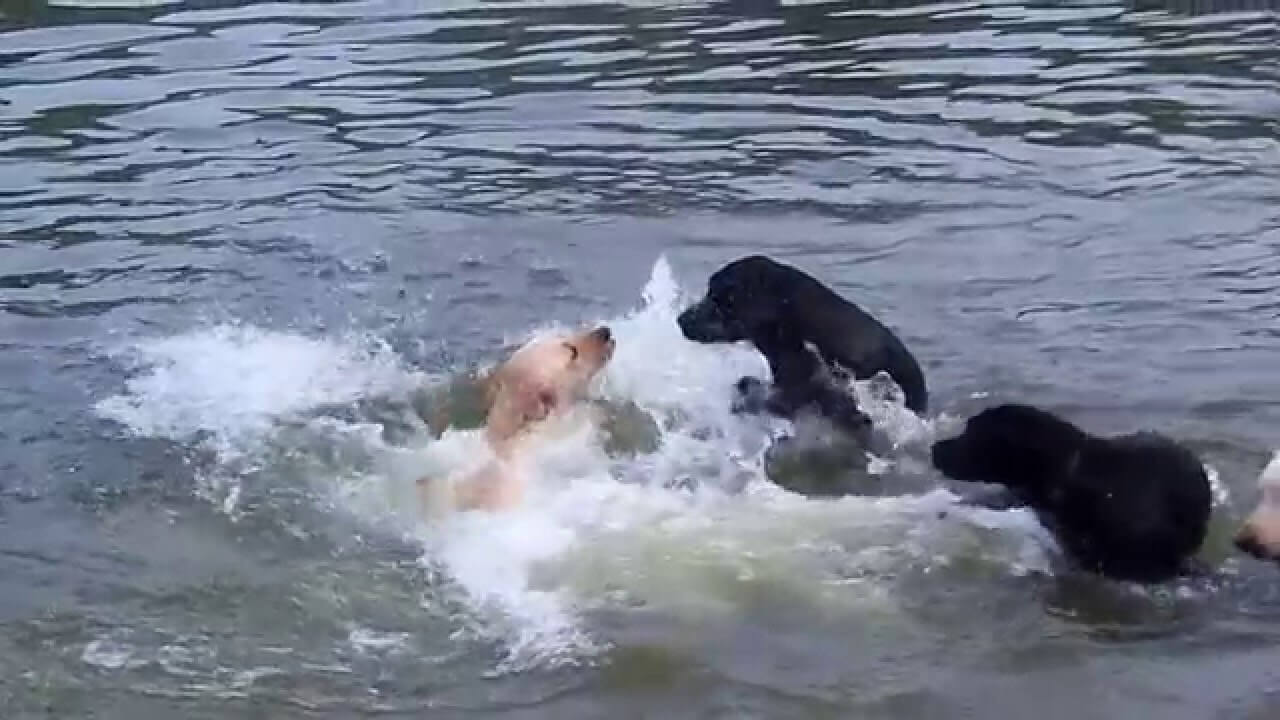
[0,0,1280,720]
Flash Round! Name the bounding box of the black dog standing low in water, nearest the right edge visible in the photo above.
[932,405,1211,582]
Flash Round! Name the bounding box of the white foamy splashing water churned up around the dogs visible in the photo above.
[97,259,1052,670]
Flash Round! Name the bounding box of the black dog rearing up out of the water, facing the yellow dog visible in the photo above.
[678,255,928,432]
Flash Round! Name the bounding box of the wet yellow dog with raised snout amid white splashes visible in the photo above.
[417,325,616,510]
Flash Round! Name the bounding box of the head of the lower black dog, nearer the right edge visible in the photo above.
[932,405,1087,491]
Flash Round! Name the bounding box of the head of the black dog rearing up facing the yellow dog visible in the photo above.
[678,255,797,342]
